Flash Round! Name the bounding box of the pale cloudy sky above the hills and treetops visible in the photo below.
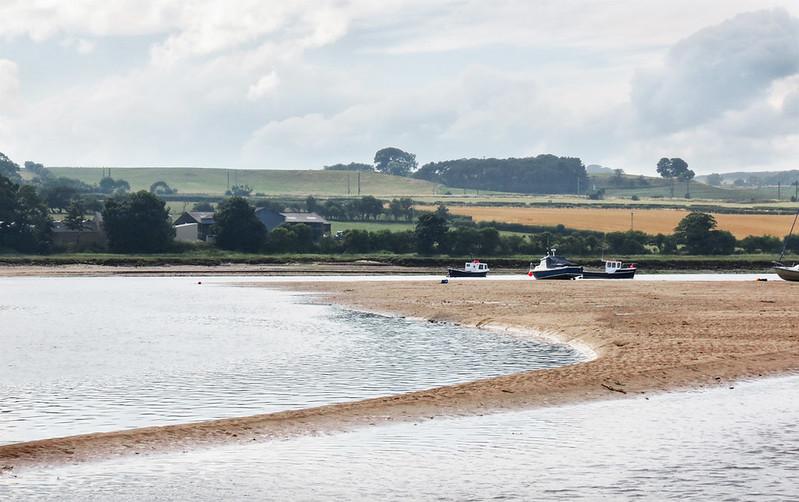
[0,0,799,174]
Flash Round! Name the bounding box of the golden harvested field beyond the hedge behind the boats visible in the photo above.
[448,206,793,239]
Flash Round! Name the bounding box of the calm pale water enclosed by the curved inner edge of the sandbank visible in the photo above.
[0,277,583,444]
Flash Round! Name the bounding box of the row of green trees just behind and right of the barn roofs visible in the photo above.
[305,195,414,221]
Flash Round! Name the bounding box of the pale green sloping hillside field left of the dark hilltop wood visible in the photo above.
[48,167,442,197]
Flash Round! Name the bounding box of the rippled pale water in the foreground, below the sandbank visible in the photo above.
[7,377,799,501]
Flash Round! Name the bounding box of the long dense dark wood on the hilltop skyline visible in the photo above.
[413,155,588,194]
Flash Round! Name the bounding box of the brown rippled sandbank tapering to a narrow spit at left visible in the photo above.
[0,281,799,467]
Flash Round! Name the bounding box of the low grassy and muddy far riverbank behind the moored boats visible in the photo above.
[0,252,799,275]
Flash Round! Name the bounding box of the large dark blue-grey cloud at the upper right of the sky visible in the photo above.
[631,9,799,132]
